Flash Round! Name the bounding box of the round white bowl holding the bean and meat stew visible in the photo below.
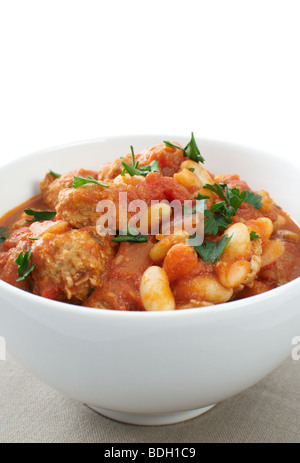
[0,135,300,424]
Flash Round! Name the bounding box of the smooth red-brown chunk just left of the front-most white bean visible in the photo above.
[84,241,153,310]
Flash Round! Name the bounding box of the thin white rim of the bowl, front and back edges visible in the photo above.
[0,133,300,319]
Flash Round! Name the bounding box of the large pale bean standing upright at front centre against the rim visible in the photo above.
[140,266,175,311]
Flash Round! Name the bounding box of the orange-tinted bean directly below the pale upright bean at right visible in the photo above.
[216,260,251,288]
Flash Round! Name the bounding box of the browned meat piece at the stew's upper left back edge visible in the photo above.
[40,169,98,210]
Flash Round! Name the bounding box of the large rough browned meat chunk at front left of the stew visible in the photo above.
[32,230,109,302]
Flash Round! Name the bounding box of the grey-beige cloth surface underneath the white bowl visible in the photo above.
[0,357,300,443]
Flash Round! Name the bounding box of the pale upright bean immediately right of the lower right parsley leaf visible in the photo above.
[221,222,250,262]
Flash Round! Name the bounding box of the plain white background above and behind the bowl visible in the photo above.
[0,0,300,169]
